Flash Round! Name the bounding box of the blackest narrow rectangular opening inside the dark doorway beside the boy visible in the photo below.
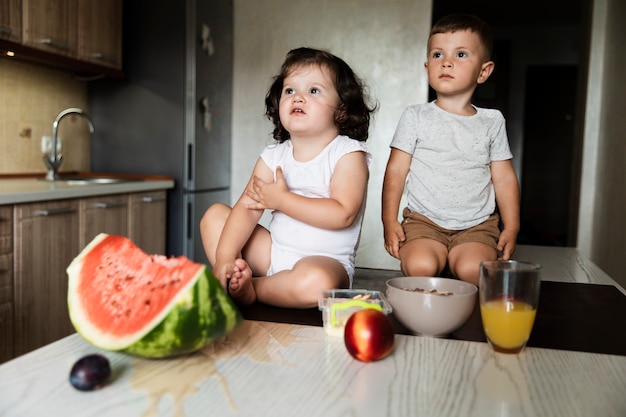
[518,65,578,246]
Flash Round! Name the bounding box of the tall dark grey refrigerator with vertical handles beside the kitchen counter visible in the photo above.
[88,0,233,263]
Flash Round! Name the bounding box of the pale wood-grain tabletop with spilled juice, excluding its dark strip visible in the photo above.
[0,246,626,417]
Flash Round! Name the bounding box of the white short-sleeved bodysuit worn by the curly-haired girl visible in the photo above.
[261,136,370,283]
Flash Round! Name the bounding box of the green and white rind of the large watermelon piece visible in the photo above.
[67,233,243,358]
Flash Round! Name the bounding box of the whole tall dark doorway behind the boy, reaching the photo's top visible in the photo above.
[430,0,593,247]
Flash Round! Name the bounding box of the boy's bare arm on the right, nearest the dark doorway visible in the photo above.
[491,160,520,260]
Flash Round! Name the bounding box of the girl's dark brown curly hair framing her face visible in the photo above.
[265,48,376,143]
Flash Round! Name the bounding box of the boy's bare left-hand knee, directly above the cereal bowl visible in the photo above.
[400,238,448,277]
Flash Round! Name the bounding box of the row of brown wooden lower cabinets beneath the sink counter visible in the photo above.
[0,190,167,363]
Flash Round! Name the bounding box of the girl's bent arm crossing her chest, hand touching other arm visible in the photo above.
[246,151,369,230]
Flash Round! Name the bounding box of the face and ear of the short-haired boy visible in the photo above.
[424,30,493,95]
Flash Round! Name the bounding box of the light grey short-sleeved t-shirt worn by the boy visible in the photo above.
[391,102,513,230]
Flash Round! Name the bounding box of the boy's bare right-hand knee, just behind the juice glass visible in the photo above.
[449,242,498,285]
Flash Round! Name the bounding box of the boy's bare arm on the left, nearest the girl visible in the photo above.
[382,148,413,258]
